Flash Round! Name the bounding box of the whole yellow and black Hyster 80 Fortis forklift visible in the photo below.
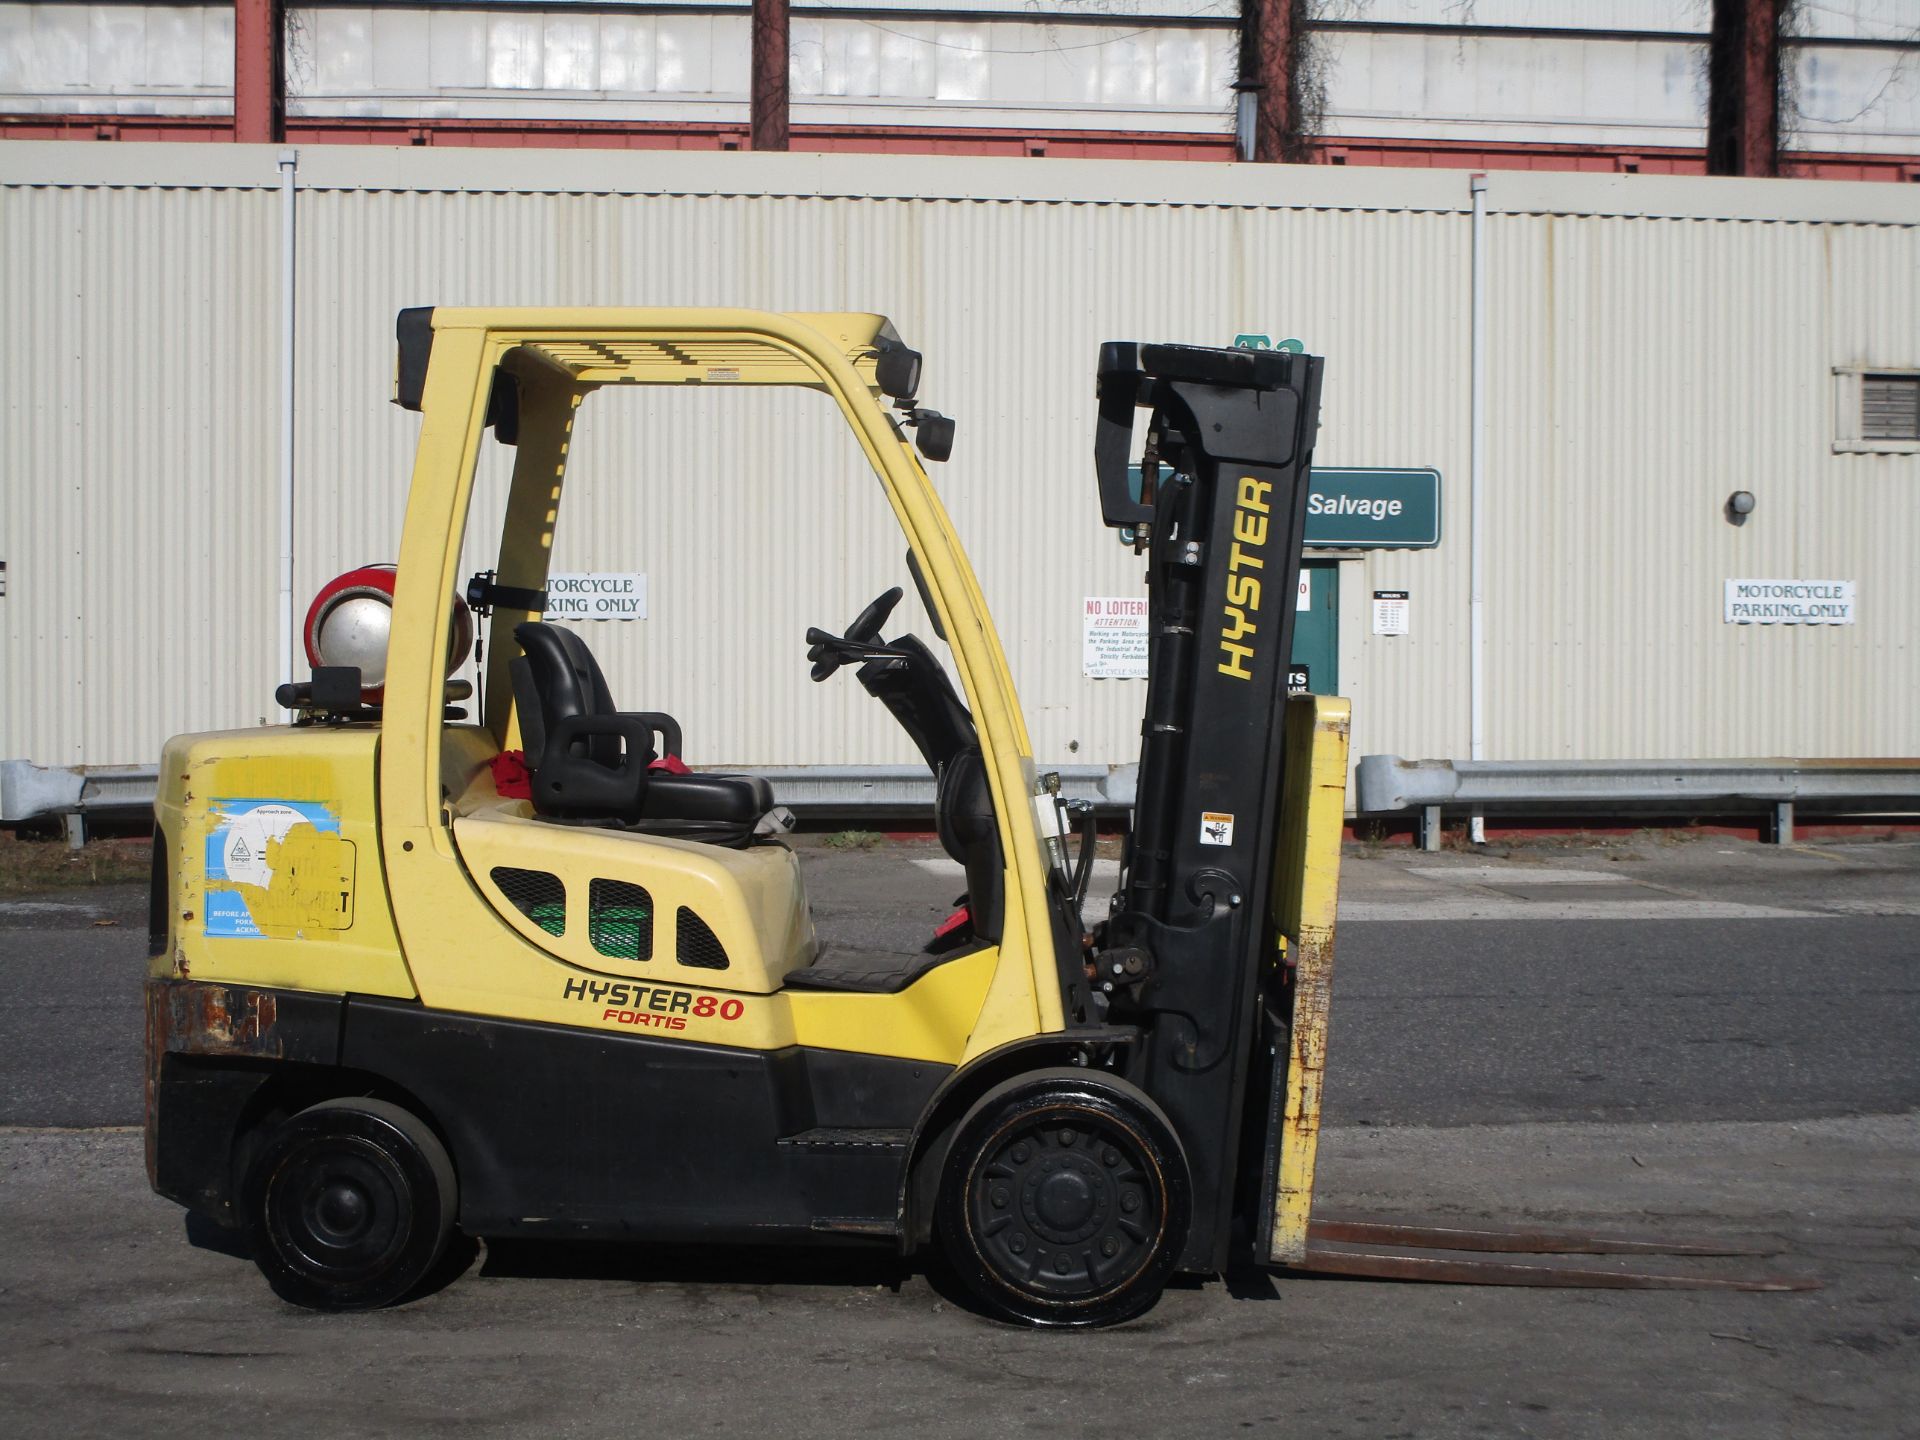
[146,307,1797,1325]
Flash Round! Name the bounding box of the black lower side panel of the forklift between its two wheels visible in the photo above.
[340,998,948,1240]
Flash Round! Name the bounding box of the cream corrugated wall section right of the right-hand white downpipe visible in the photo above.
[1488,215,1920,758]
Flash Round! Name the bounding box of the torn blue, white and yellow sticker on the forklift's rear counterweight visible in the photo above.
[202,799,353,939]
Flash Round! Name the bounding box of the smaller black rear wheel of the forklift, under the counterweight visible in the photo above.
[246,1100,459,1309]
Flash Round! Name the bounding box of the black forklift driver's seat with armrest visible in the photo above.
[509,620,774,845]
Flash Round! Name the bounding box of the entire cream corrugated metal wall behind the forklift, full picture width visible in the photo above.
[0,144,1920,779]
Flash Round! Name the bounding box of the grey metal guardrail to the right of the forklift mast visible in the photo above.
[1354,755,1920,851]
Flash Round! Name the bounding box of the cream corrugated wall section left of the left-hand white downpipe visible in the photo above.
[0,177,278,764]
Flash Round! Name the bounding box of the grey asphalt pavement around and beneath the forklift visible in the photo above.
[0,839,1920,1440]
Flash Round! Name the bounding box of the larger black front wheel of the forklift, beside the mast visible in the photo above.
[935,1069,1192,1327]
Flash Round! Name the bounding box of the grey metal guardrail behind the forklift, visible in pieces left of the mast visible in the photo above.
[0,760,1139,845]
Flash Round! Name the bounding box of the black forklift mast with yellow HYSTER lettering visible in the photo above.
[1094,342,1323,1271]
